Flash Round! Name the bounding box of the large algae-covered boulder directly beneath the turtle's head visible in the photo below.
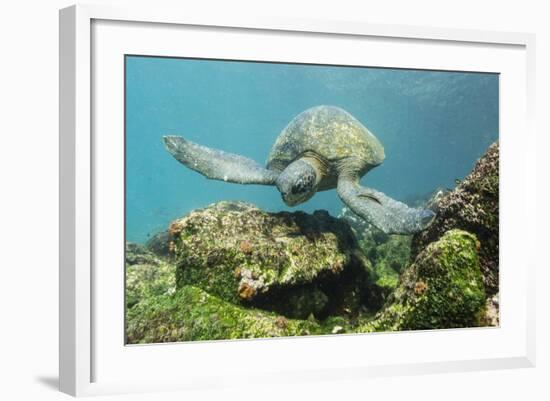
[169,202,371,318]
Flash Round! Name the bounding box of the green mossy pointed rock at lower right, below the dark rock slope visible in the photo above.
[358,230,485,332]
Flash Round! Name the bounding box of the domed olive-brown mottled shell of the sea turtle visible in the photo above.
[267,106,384,171]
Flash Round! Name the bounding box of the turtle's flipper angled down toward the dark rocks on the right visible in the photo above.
[338,177,435,235]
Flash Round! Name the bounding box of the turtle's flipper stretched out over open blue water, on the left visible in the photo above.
[164,135,278,185]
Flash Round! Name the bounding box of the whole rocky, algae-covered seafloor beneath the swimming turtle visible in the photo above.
[126,143,499,344]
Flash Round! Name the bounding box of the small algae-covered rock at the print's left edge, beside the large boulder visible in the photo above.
[125,243,176,308]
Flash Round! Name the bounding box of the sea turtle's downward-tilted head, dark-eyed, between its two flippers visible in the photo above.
[275,159,319,206]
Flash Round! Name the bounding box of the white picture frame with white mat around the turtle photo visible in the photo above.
[59,5,536,396]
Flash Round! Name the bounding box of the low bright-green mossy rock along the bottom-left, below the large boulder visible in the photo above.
[126,286,320,344]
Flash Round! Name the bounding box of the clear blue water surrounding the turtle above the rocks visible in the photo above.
[126,56,499,242]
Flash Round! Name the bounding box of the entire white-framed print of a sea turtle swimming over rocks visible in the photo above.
[60,6,535,395]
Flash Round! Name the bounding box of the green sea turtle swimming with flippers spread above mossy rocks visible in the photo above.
[164,106,435,234]
